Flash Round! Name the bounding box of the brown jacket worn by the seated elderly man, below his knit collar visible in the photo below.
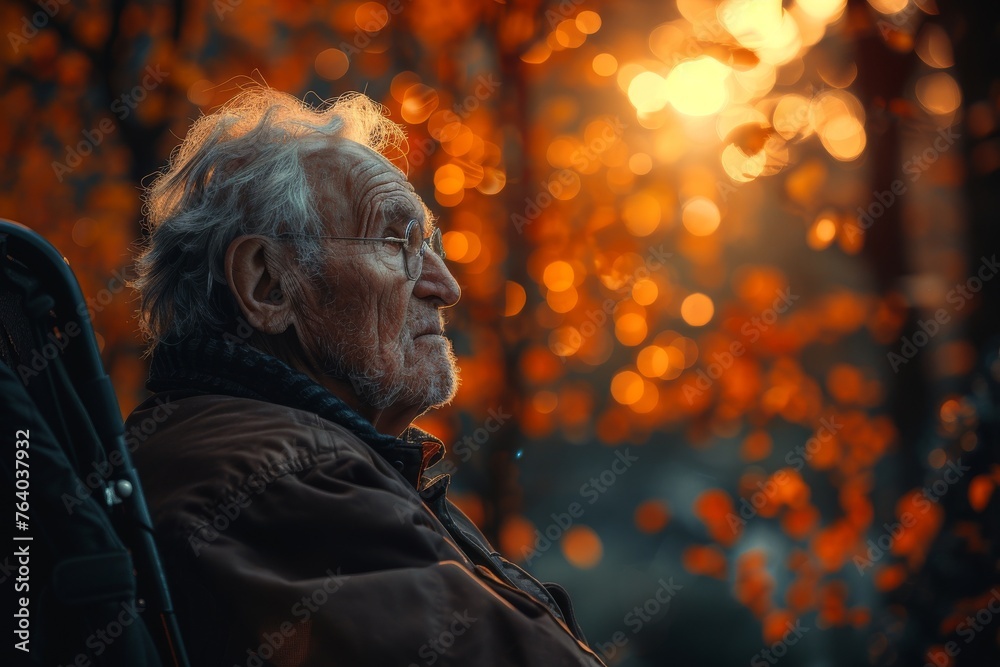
[126,392,602,667]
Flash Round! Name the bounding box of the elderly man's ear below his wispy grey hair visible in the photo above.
[225,236,295,336]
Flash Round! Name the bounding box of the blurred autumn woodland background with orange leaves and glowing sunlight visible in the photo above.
[0,0,1000,667]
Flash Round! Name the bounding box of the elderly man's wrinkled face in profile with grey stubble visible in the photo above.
[292,139,460,420]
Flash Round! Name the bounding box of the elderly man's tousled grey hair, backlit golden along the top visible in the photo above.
[132,86,405,350]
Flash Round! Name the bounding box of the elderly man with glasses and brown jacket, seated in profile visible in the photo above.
[126,88,601,667]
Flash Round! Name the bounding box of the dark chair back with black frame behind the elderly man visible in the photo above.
[0,219,189,667]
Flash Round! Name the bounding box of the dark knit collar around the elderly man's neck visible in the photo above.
[146,335,443,486]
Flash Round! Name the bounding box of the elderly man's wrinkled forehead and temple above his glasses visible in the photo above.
[306,138,434,236]
